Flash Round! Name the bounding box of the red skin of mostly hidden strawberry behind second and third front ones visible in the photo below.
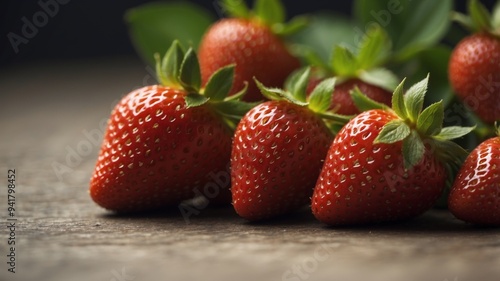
[307,78,392,115]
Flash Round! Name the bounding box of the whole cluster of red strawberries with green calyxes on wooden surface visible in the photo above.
[90,1,500,225]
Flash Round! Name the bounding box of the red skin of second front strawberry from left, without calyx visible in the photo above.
[231,101,332,220]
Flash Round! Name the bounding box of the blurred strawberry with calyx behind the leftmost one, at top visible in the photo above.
[199,0,300,101]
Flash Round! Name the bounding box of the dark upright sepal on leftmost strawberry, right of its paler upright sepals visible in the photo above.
[179,48,201,93]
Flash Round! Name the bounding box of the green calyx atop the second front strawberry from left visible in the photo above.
[254,67,353,125]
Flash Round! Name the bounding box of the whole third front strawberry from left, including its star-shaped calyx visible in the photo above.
[312,75,473,225]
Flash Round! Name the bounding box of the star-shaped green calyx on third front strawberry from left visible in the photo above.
[352,76,474,170]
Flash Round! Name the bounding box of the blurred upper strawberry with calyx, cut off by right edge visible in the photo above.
[448,1,500,124]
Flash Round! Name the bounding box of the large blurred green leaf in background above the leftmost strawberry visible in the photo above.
[125,1,215,65]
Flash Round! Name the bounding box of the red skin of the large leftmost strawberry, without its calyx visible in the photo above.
[90,86,231,212]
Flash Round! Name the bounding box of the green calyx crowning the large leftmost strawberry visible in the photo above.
[155,40,255,127]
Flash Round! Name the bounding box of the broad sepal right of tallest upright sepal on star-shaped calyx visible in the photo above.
[417,101,444,136]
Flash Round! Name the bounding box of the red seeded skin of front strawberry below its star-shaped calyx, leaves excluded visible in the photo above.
[312,110,446,225]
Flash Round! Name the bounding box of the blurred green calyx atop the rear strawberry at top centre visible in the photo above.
[221,0,308,36]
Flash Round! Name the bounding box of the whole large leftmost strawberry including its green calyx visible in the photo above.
[90,42,254,212]
